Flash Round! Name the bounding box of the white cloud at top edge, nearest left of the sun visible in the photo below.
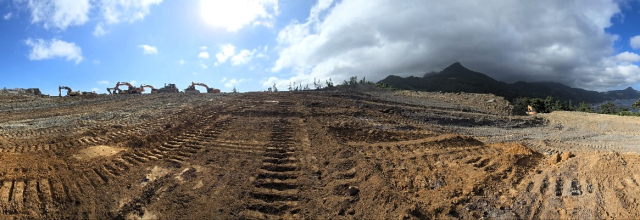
[98,0,162,24]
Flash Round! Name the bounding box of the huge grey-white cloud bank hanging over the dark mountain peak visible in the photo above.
[272,0,640,90]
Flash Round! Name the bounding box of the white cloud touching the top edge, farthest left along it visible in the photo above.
[18,0,91,30]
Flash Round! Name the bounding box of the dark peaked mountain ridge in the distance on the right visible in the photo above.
[379,62,640,104]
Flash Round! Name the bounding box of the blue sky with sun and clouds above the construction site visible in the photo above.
[0,0,640,95]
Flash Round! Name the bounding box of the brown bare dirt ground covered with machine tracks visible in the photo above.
[0,90,640,219]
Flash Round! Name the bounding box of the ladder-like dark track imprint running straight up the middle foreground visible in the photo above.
[244,119,301,219]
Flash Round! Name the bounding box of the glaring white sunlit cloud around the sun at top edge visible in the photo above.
[200,0,279,31]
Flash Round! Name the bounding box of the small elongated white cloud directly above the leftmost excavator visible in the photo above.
[25,38,84,65]
